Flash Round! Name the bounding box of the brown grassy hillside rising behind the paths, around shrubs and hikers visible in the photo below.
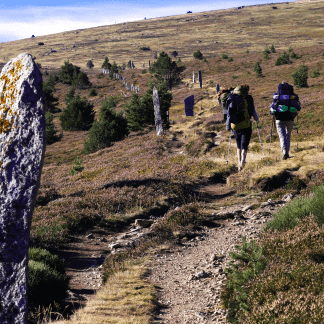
[0,1,324,323]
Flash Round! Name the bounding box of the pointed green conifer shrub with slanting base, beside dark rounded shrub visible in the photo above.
[84,97,129,154]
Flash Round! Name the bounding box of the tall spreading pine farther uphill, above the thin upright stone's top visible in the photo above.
[149,52,186,89]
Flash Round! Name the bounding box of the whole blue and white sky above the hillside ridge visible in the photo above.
[0,0,296,42]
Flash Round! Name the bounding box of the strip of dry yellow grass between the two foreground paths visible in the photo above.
[55,259,156,324]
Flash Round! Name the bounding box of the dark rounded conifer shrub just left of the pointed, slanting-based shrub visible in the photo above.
[59,95,95,131]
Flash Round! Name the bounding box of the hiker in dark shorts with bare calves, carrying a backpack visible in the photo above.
[226,85,259,171]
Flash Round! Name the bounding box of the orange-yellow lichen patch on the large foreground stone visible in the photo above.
[0,61,23,133]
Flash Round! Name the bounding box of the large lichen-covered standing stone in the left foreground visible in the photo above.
[0,53,45,324]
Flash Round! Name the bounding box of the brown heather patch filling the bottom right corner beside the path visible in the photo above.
[238,217,324,324]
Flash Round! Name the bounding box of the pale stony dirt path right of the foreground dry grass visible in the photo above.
[150,198,290,324]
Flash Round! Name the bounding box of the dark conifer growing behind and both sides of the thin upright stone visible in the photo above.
[125,80,173,131]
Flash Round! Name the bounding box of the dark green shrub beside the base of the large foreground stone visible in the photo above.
[27,248,69,307]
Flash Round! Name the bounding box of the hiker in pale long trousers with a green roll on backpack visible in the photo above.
[270,82,301,160]
